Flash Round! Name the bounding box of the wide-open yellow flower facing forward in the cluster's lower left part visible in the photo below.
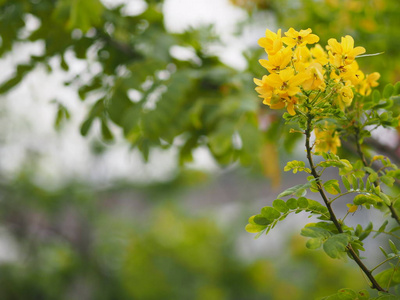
[265,68,309,96]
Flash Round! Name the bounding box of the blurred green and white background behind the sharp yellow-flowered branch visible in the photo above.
[0,0,400,300]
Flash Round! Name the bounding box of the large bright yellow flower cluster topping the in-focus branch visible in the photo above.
[254,28,380,115]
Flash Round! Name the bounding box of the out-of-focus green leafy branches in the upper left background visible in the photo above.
[0,0,265,170]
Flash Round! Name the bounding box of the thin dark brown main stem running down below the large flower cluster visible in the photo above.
[305,113,387,292]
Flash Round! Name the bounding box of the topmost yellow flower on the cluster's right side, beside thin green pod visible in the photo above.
[326,35,365,68]
